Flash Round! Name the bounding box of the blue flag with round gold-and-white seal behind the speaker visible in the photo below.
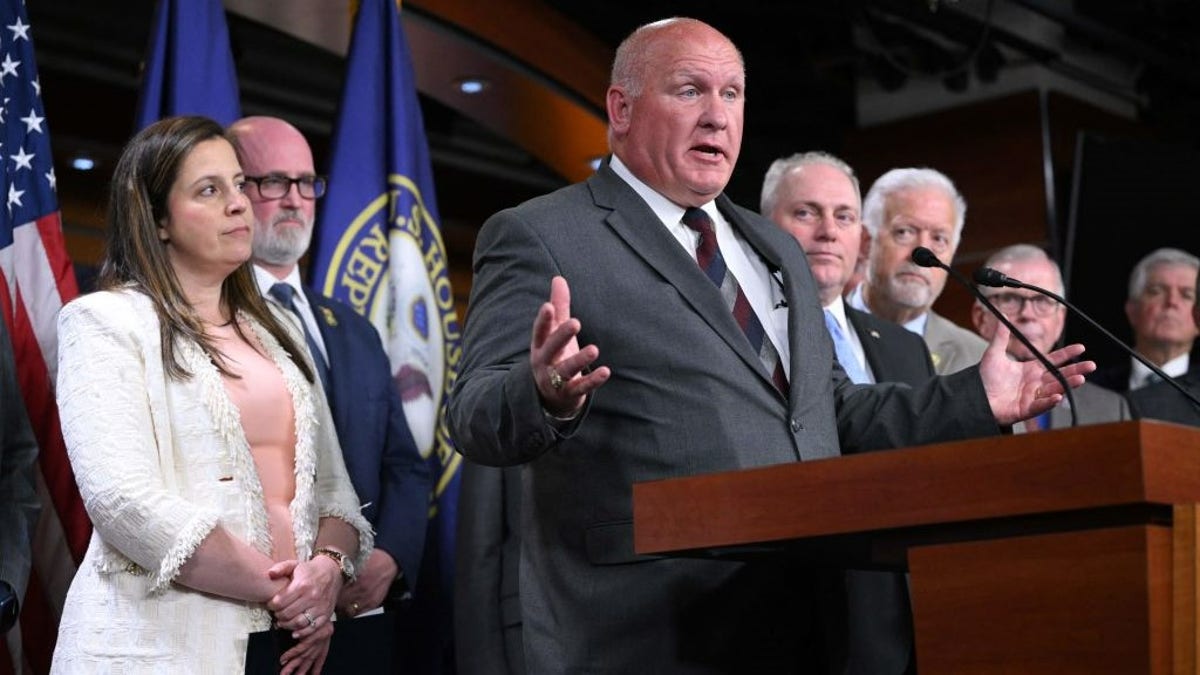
[311,0,462,674]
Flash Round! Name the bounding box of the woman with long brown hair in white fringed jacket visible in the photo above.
[53,118,372,674]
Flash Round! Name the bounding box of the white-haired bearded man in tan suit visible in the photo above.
[846,168,988,375]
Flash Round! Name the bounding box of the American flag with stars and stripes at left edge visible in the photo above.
[0,0,91,673]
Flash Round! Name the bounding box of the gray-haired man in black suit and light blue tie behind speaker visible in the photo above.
[761,153,936,675]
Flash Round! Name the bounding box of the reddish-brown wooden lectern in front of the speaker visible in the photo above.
[634,420,1200,675]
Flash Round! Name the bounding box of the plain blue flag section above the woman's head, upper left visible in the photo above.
[137,0,241,130]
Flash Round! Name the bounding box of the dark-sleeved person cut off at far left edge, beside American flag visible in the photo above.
[0,317,41,638]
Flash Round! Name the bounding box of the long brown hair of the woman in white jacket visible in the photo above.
[97,117,313,382]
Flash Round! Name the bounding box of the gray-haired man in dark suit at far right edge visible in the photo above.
[1088,249,1200,392]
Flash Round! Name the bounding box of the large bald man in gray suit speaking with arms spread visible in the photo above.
[449,18,1094,674]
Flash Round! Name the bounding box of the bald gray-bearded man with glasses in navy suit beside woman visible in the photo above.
[229,117,432,616]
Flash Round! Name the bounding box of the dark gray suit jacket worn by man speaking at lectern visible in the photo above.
[449,166,998,674]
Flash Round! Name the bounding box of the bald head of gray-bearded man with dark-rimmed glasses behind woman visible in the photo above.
[229,117,317,279]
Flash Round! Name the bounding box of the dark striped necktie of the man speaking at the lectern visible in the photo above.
[683,208,787,396]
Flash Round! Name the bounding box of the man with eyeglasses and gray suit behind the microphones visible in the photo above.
[971,244,1130,431]
